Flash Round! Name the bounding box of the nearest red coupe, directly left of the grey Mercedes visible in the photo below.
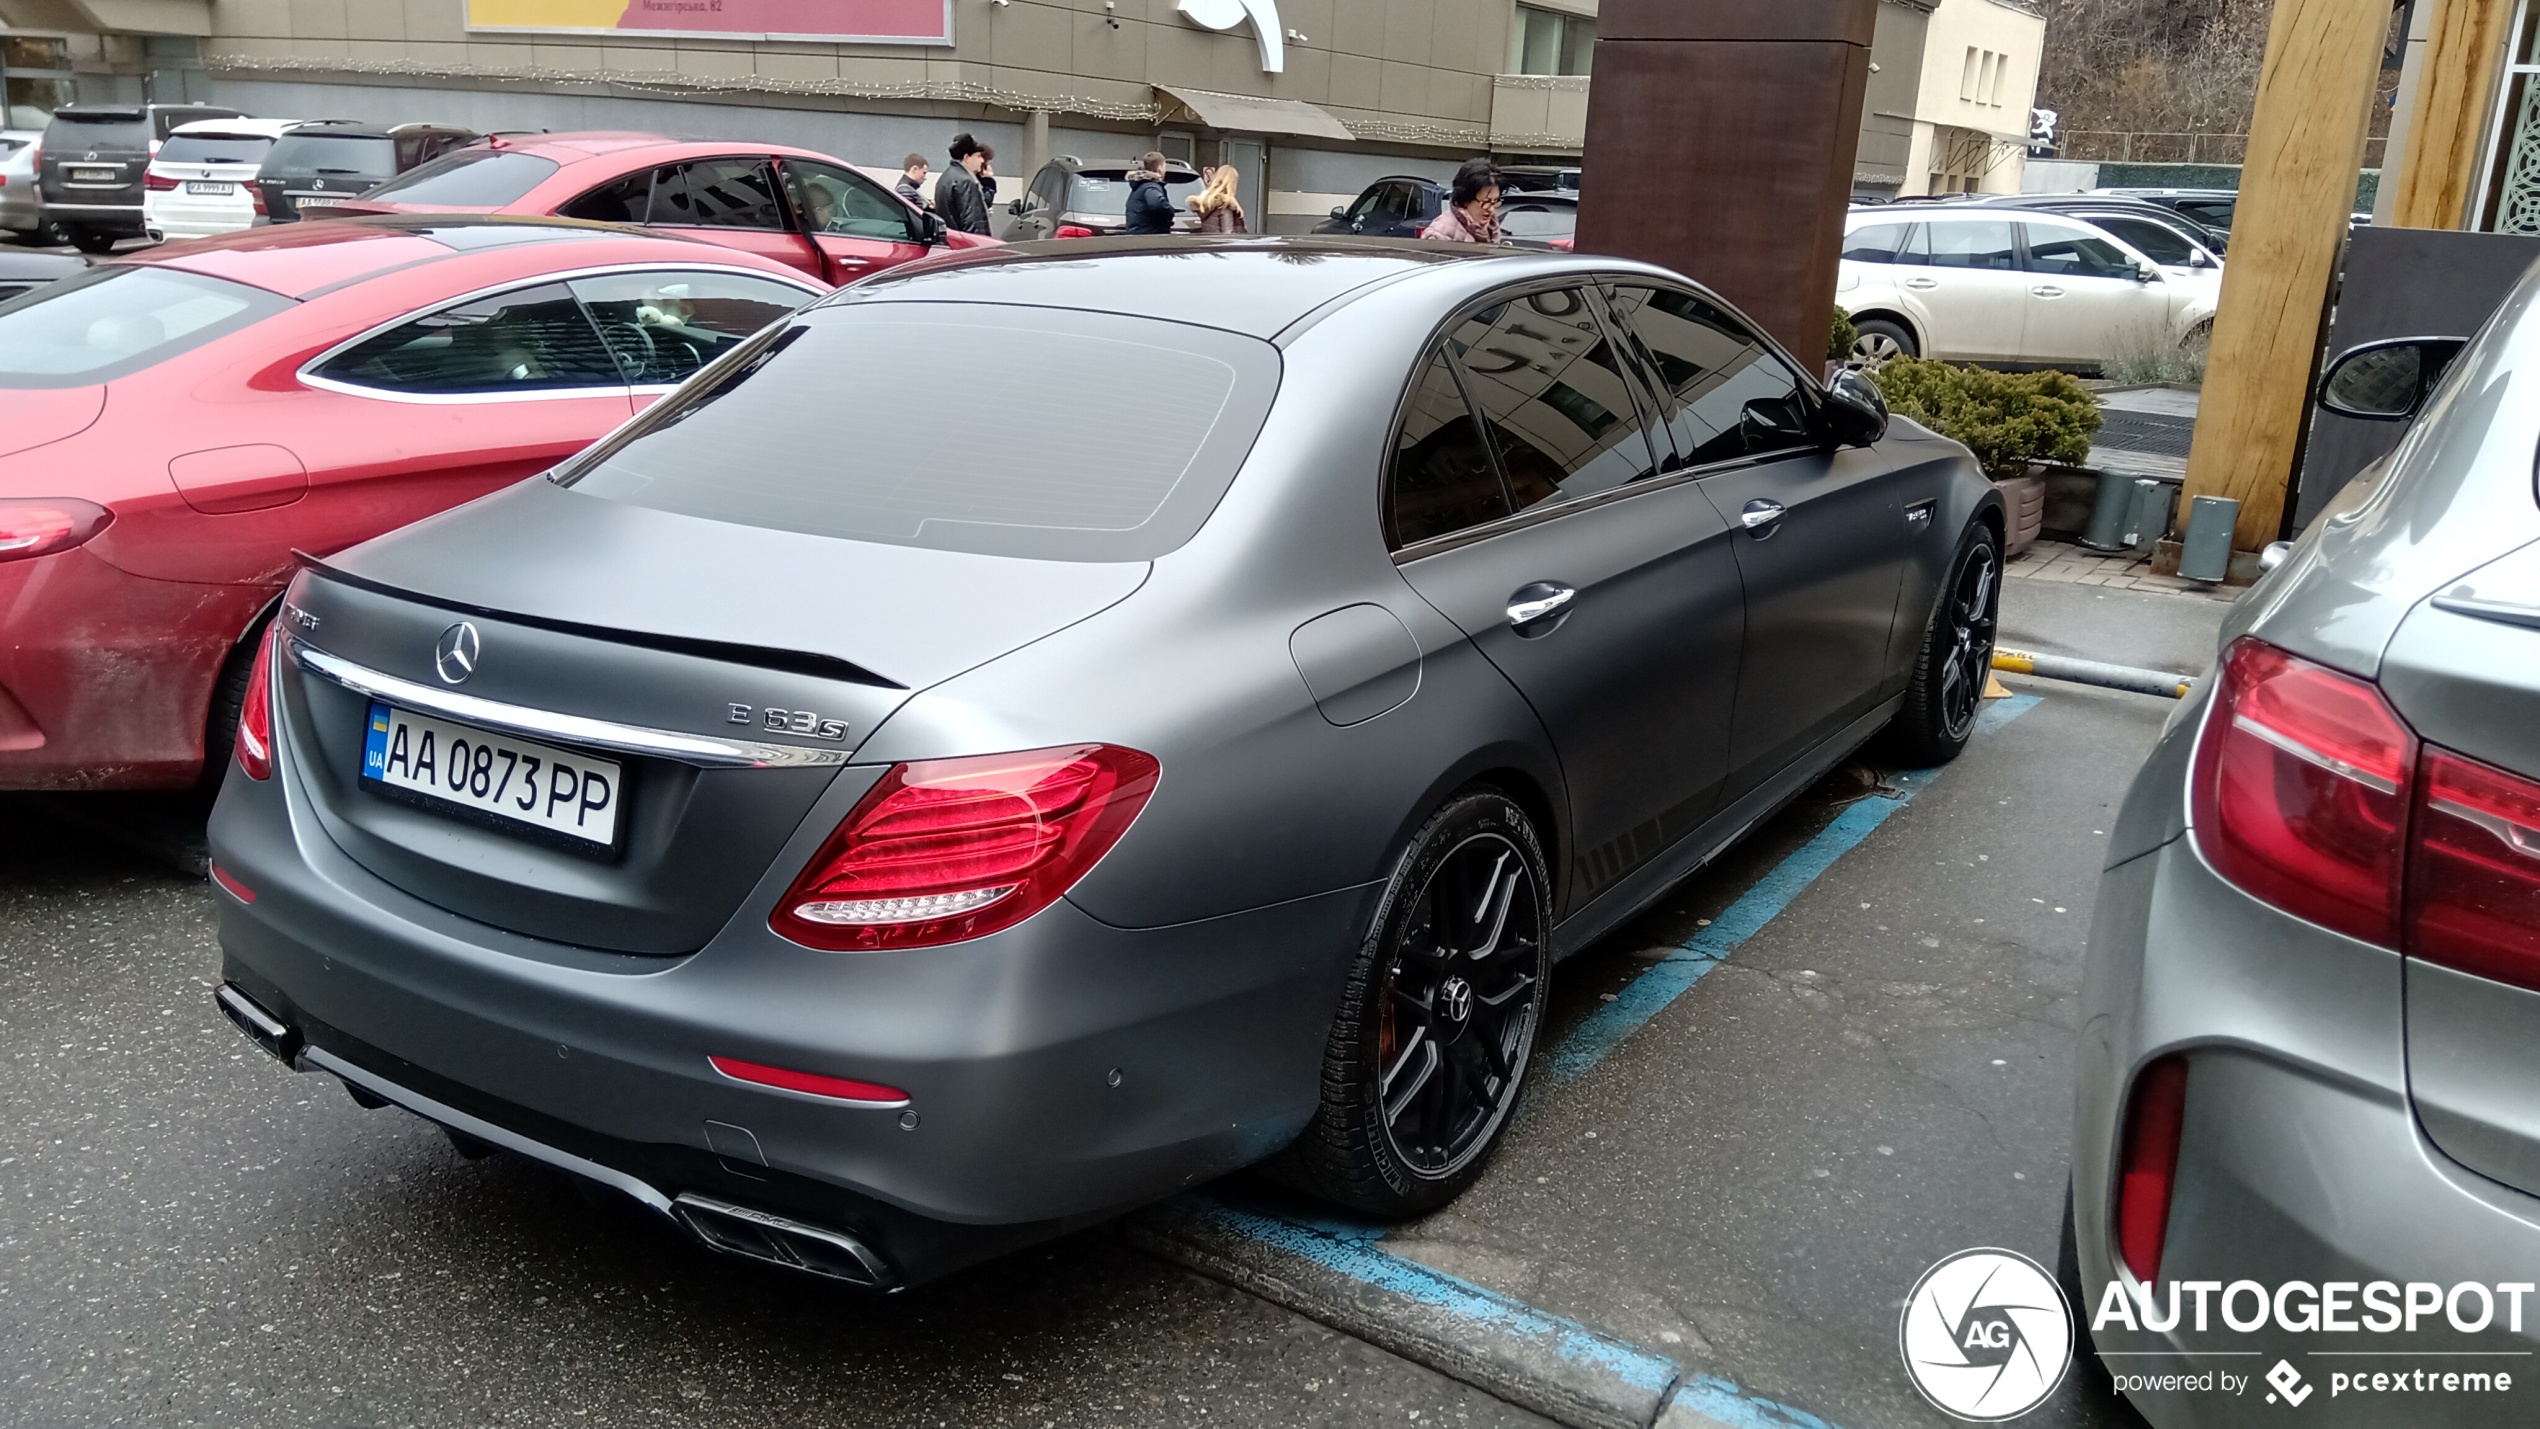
[0,218,823,789]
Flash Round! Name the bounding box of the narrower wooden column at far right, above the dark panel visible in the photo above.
[2390,0,2515,228]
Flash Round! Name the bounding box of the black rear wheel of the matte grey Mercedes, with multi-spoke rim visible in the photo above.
[1275,787,1552,1216]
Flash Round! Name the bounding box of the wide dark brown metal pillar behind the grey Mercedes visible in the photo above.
[1577,0,1880,363]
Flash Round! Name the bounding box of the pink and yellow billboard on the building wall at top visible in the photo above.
[467,0,953,46]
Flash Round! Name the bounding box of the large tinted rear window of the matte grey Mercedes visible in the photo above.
[559,302,1280,561]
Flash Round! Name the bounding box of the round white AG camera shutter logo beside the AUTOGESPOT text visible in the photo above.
[1897,1246,2073,1424]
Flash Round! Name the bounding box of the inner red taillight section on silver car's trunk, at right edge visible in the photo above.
[2408,746,2540,987]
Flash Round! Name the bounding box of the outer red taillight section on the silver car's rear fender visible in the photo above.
[2192,640,2416,947]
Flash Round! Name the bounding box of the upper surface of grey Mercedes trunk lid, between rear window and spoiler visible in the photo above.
[328,477,1148,690]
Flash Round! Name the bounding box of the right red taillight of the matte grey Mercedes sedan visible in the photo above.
[770,744,1156,952]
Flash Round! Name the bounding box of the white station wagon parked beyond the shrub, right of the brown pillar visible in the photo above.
[1834,203,2223,371]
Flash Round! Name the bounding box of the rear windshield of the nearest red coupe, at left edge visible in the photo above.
[0,267,292,388]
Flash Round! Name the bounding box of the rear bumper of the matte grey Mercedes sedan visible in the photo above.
[211,730,1367,1274]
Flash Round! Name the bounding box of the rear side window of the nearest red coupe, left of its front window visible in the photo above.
[315,282,625,396]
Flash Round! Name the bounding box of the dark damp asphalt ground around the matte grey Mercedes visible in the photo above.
[0,581,2225,1429]
